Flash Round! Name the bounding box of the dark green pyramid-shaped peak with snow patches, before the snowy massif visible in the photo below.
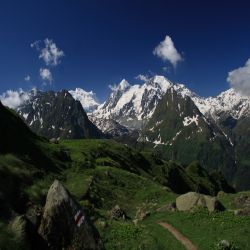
[142,86,235,182]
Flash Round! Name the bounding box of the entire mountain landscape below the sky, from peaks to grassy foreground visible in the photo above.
[0,76,250,250]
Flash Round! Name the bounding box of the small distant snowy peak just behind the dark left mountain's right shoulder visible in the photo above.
[69,88,100,113]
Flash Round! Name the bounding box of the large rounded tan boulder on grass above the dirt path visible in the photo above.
[176,192,223,212]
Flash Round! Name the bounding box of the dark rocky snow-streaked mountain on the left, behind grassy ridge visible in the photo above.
[17,90,103,139]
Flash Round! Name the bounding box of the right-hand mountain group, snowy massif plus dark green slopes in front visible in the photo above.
[89,76,250,190]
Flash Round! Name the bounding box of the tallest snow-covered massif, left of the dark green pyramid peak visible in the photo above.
[92,76,173,129]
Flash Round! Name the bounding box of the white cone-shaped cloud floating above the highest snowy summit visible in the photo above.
[153,36,183,67]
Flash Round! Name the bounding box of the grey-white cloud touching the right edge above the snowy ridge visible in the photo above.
[227,58,250,96]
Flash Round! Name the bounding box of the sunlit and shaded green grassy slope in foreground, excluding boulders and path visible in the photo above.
[0,102,250,250]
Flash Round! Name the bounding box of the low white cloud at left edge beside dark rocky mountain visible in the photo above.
[0,89,30,109]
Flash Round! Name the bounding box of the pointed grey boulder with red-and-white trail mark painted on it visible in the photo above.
[39,180,104,250]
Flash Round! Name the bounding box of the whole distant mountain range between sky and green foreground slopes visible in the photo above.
[1,76,250,189]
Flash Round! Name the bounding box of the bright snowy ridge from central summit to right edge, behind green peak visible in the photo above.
[92,76,250,129]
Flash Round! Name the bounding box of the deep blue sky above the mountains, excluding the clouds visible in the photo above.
[0,0,250,100]
